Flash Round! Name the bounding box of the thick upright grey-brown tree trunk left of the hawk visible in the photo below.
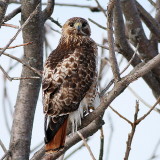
[9,0,43,160]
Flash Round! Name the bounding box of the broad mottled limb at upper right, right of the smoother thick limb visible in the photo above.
[121,0,160,85]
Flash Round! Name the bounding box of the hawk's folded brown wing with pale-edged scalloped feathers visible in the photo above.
[42,48,96,117]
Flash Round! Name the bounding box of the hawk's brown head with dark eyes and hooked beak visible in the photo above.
[62,17,91,36]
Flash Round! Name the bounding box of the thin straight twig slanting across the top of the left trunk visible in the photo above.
[0,4,40,56]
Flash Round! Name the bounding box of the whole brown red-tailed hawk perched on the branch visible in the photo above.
[42,17,97,151]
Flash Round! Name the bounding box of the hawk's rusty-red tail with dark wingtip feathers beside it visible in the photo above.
[45,115,68,152]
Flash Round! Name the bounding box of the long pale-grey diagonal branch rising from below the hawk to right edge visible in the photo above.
[32,48,160,160]
